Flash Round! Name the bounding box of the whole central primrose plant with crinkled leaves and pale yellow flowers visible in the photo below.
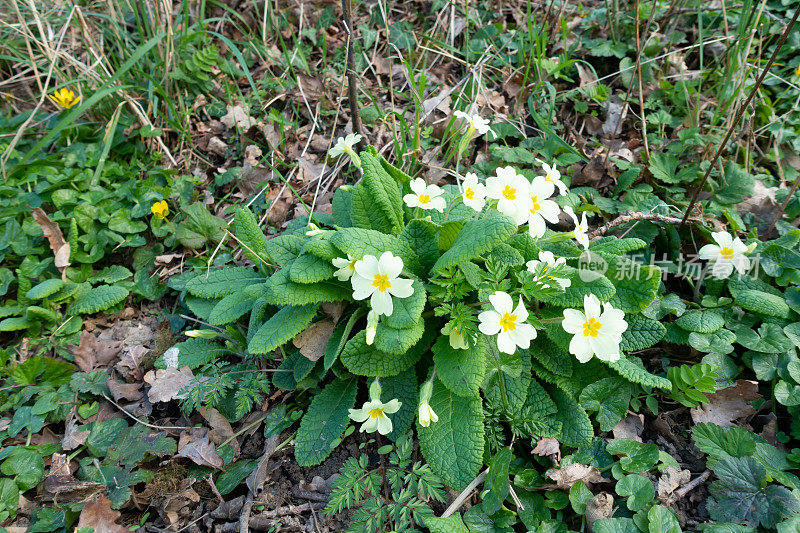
[178,127,671,488]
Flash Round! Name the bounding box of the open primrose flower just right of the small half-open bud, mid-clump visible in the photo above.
[478,291,536,354]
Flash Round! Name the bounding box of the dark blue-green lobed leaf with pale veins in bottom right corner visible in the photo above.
[707,457,798,528]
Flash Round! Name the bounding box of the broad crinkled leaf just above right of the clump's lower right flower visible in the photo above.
[605,256,661,313]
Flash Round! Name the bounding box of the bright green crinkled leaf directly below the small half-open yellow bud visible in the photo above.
[431,335,486,396]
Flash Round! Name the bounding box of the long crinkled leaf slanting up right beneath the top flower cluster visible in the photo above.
[431,214,517,272]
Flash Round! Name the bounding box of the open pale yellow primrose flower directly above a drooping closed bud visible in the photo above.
[350,252,414,316]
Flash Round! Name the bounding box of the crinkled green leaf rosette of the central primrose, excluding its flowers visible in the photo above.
[180,147,671,488]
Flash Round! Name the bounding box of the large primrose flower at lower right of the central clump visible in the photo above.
[561,294,628,363]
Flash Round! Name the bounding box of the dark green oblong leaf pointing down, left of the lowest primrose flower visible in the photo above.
[294,379,358,466]
